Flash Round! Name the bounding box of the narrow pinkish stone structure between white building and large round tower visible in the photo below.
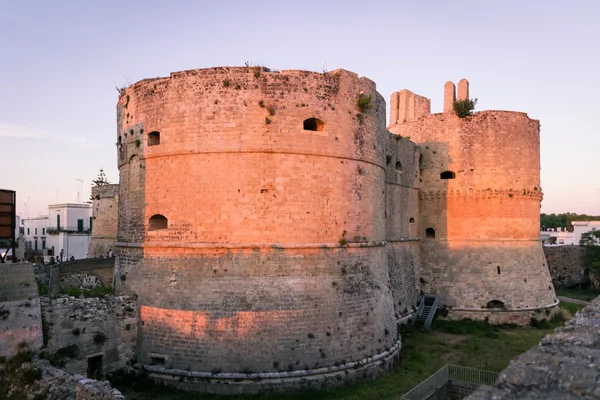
[88,185,119,258]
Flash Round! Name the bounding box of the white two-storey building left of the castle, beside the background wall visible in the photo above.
[47,203,92,261]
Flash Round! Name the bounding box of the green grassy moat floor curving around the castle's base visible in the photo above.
[113,300,584,400]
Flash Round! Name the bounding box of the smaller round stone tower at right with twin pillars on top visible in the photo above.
[390,80,558,323]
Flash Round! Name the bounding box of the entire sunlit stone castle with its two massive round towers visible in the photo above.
[114,67,558,391]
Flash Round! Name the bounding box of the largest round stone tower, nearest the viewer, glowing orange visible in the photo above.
[115,67,399,392]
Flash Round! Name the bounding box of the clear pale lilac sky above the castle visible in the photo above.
[0,0,600,218]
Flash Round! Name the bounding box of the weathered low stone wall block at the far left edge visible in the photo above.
[0,263,42,358]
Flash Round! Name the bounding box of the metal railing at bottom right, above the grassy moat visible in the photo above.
[402,364,498,400]
